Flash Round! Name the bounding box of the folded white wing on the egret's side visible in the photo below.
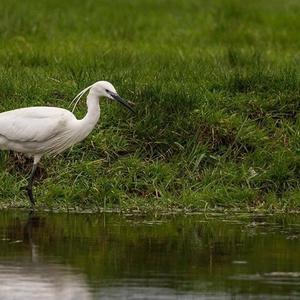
[0,107,75,142]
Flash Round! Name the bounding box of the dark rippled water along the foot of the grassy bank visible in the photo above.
[0,211,300,300]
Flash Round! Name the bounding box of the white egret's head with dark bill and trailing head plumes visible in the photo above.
[72,81,134,113]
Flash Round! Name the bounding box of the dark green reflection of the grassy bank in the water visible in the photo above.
[0,211,300,294]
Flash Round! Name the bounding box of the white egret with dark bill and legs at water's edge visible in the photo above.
[0,81,134,207]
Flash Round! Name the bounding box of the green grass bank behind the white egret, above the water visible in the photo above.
[0,0,300,211]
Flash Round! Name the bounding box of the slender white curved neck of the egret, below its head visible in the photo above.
[81,90,100,133]
